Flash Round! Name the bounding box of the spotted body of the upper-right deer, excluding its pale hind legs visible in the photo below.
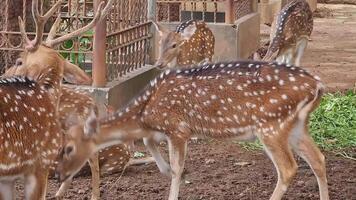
[264,0,313,61]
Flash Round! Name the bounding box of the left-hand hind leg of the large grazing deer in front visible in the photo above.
[261,133,298,200]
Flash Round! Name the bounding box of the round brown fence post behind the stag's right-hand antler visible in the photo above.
[92,0,106,87]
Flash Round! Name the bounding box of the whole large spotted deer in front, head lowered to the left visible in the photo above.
[58,61,329,200]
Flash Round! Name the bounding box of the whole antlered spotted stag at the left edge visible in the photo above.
[0,0,112,200]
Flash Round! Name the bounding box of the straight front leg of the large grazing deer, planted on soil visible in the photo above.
[168,139,187,200]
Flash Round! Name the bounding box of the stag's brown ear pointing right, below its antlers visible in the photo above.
[63,60,92,85]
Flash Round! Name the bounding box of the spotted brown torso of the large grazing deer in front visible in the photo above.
[138,61,319,138]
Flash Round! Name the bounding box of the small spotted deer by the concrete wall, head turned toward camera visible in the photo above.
[153,20,215,69]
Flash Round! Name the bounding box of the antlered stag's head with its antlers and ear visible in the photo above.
[11,0,112,92]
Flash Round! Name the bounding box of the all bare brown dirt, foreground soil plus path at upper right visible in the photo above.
[35,5,356,200]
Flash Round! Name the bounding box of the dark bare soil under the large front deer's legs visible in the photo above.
[45,141,356,200]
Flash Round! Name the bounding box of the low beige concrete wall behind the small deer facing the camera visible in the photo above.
[151,13,260,61]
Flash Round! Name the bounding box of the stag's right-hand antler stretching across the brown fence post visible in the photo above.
[45,0,113,47]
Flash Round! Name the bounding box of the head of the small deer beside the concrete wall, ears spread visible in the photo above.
[152,22,197,69]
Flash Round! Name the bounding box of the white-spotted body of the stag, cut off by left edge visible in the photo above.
[0,77,60,176]
